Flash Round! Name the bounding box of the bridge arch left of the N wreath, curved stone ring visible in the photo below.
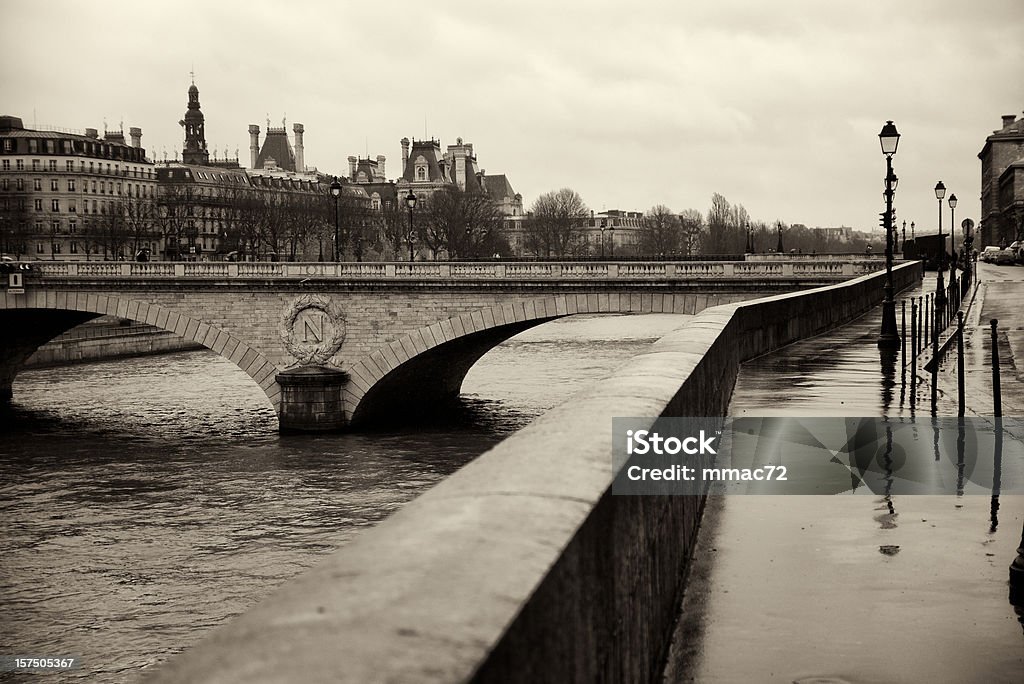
[0,292,281,412]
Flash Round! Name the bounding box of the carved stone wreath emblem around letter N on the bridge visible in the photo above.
[281,295,345,366]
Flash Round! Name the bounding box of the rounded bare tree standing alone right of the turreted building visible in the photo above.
[523,187,590,257]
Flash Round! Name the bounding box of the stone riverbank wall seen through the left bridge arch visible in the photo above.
[23,316,203,369]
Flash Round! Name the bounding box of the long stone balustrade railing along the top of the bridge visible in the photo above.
[30,257,885,282]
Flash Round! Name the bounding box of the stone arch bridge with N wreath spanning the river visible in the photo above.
[0,258,883,430]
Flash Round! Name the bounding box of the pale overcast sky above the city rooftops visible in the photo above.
[6,0,1024,230]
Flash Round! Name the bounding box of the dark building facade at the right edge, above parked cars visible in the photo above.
[974,115,1024,248]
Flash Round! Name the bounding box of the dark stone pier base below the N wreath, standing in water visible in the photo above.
[274,366,348,432]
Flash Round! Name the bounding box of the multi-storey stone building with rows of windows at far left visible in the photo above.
[0,116,159,260]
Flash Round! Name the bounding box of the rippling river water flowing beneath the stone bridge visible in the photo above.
[0,314,688,682]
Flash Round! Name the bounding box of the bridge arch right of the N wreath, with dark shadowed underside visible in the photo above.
[344,293,712,427]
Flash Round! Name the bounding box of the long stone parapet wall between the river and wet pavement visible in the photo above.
[154,262,922,682]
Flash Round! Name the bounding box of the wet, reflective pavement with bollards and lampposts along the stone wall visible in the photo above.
[665,264,1024,683]
